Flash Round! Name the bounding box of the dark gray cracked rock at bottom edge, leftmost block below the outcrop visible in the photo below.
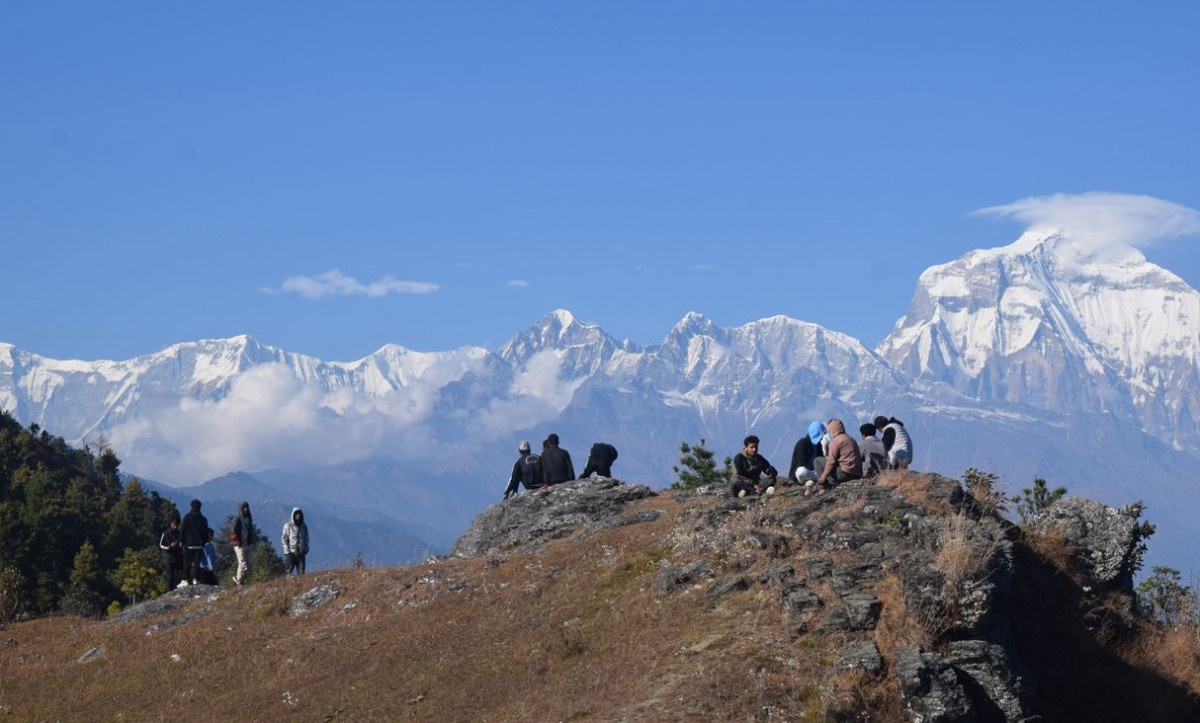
[892,647,978,723]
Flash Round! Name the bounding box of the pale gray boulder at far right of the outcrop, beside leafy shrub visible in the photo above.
[1030,496,1138,590]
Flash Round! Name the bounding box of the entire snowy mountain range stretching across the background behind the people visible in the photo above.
[0,229,1200,570]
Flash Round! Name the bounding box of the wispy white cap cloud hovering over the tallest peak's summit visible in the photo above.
[974,191,1200,255]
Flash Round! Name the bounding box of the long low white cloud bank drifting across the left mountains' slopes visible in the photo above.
[106,351,582,484]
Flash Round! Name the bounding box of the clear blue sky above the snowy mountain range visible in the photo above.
[0,1,1200,360]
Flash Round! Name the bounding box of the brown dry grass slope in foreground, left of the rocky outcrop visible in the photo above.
[0,496,902,722]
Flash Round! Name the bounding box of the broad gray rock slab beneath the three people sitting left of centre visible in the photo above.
[450,477,660,557]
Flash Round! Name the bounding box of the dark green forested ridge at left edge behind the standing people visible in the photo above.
[0,411,179,621]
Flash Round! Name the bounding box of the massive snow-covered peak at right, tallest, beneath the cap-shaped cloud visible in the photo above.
[877,231,1200,452]
